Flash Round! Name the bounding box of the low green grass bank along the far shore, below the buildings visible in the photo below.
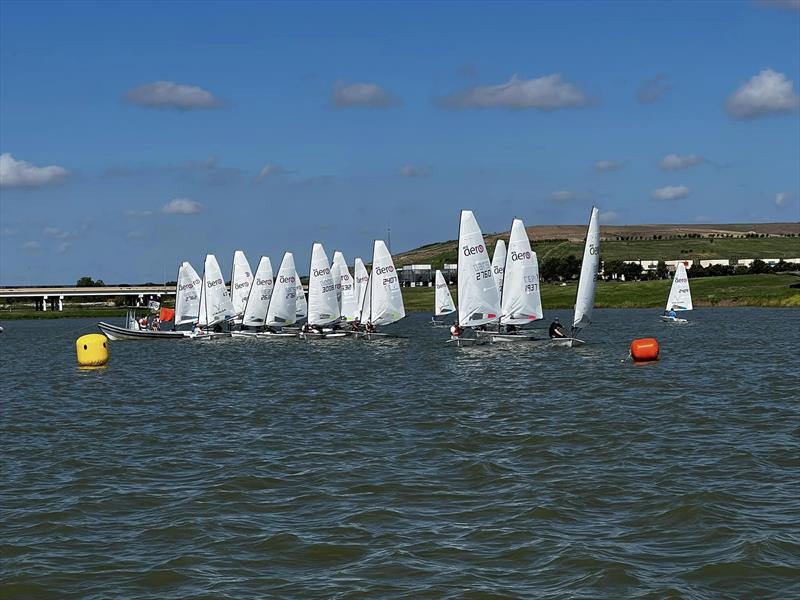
[403,274,800,312]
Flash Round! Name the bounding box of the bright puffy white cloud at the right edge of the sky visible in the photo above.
[725,69,800,119]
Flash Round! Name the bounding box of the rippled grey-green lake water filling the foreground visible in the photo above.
[0,308,800,599]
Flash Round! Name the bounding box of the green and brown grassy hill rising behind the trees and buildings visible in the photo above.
[394,223,800,268]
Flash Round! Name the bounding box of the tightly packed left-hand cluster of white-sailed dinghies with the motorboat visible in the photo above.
[98,240,405,340]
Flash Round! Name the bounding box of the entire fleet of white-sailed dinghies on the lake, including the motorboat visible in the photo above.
[98,207,692,347]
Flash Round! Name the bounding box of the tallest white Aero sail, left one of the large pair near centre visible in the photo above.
[458,210,500,327]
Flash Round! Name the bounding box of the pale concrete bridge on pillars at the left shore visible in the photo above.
[0,285,175,311]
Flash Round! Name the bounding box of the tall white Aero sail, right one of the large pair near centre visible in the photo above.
[495,219,544,325]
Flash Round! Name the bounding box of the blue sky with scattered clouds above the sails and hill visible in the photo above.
[0,0,800,285]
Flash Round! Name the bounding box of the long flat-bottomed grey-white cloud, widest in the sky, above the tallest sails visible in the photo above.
[438,73,592,111]
